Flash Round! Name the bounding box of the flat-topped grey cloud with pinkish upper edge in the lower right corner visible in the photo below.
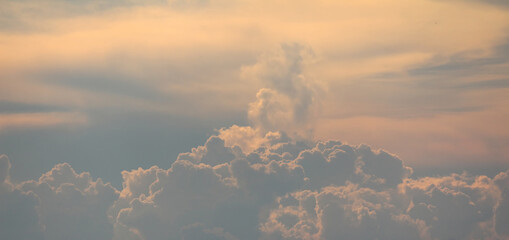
[400,174,501,239]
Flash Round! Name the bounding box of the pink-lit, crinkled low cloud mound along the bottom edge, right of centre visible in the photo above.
[261,183,429,239]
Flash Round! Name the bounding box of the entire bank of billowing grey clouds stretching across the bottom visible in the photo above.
[0,131,509,240]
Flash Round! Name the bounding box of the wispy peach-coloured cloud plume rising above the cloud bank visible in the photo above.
[243,43,318,136]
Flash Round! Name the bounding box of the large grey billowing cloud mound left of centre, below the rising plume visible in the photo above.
[115,132,304,239]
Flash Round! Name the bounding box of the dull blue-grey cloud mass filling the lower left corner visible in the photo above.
[0,155,119,240]
